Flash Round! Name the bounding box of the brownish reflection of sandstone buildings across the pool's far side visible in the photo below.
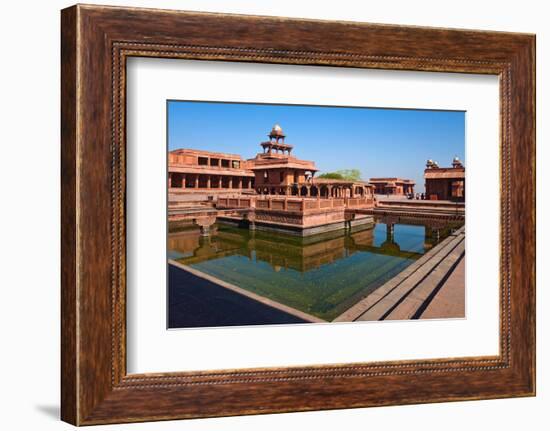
[168,223,458,272]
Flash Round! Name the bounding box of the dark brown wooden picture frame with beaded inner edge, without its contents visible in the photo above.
[61,5,535,425]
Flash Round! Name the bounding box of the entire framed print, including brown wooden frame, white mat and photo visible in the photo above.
[61,5,535,425]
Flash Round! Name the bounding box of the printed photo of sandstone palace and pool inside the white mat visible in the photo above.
[167,100,465,328]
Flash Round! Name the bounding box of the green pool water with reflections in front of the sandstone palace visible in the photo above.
[168,224,462,321]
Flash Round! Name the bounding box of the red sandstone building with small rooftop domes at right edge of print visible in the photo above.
[424,157,466,202]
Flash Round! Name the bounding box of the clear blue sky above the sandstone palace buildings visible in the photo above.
[168,101,465,192]
